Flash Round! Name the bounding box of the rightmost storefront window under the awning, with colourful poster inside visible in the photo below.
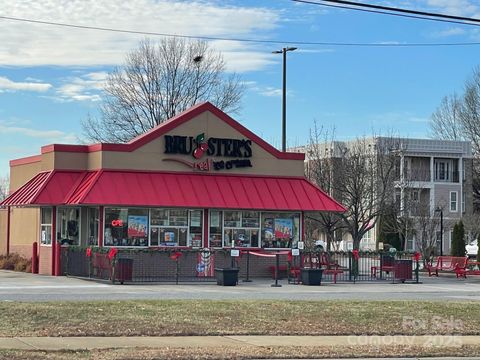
[262,213,300,248]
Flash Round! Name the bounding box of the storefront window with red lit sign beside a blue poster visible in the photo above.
[104,208,148,246]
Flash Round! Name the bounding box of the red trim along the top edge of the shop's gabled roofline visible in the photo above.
[38,102,305,161]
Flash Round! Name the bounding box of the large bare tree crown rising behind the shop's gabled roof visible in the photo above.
[82,38,243,142]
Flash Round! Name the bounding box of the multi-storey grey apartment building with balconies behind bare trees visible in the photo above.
[298,137,473,254]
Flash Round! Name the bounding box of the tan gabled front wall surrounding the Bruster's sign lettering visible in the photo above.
[103,112,304,176]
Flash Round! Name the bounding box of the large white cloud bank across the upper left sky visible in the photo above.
[0,0,281,71]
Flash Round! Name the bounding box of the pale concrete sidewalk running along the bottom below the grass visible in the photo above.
[0,335,480,350]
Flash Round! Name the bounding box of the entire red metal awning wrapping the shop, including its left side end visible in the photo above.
[0,170,345,212]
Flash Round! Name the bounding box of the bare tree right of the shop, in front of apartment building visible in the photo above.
[309,132,399,249]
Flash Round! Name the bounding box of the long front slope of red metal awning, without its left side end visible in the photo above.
[66,171,345,212]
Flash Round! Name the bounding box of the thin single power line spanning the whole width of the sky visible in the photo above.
[0,14,480,48]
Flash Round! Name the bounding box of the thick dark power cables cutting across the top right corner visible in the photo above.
[291,0,480,26]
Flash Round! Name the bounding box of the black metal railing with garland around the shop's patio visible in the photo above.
[62,246,418,283]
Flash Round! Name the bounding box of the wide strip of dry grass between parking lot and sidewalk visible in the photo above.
[0,300,480,337]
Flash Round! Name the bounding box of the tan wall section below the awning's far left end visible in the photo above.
[10,207,40,246]
